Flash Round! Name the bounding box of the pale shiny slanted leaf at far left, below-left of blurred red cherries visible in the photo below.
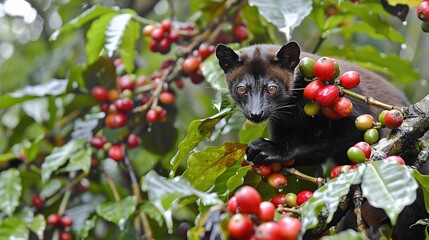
[42,140,85,184]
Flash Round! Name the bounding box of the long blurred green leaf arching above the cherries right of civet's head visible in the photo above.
[320,45,420,83]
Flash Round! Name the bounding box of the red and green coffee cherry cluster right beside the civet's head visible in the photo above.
[299,57,360,119]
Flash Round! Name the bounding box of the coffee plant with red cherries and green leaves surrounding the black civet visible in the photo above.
[0,0,429,240]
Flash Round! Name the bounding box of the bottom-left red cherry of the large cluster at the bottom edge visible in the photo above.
[227,214,253,240]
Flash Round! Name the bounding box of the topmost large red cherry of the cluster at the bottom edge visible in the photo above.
[234,186,262,214]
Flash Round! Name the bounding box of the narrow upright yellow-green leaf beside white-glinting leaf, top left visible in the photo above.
[119,16,141,73]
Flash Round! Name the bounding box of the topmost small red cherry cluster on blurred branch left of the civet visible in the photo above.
[143,19,180,54]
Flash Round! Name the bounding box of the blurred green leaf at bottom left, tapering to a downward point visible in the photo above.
[97,196,137,231]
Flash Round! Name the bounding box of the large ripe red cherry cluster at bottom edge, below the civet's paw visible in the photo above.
[227,186,302,240]
